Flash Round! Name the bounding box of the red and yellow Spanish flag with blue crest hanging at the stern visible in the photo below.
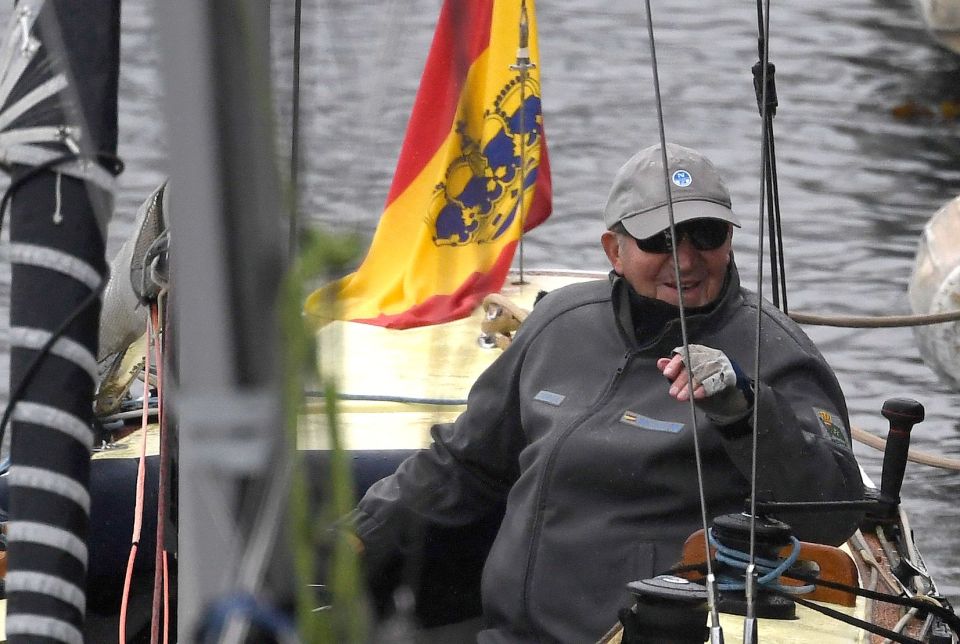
[305,0,551,329]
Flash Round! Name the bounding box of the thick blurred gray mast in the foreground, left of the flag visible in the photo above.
[157,0,289,641]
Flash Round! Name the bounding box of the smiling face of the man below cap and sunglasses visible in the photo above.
[601,221,732,307]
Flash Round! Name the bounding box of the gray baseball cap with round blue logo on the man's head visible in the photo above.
[603,143,740,239]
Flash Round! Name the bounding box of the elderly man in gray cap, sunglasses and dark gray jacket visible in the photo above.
[354,145,862,642]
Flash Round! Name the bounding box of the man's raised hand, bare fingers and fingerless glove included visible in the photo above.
[657,344,753,425]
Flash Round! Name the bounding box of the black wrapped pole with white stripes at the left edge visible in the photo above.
[0,0,119,644]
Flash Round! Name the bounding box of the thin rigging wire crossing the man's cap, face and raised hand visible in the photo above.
[645,0,723,644]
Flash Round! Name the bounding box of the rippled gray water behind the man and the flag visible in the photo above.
[0,0,960,603]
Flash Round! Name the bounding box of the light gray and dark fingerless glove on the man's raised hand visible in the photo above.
[673,344,753,426]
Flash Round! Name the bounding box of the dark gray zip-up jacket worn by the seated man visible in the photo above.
[354,264,863,643]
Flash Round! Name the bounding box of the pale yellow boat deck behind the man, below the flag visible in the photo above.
[298,271,604,450]
